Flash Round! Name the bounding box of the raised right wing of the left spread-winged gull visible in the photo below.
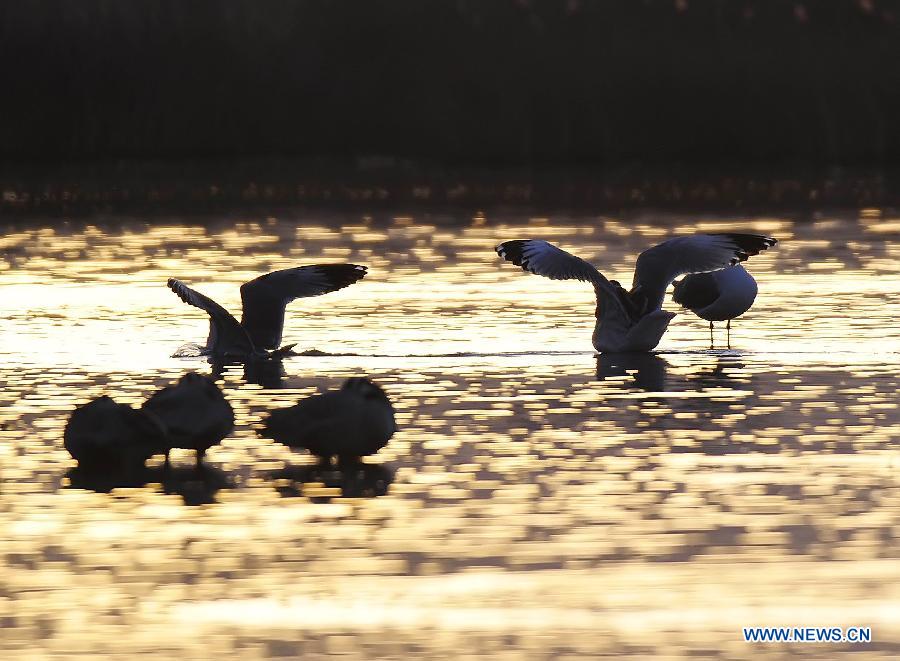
[241,264,366,349]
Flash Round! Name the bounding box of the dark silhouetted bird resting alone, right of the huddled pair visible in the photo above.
[263,377,397,465]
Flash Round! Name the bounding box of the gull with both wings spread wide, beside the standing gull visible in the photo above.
[495,233,777,353]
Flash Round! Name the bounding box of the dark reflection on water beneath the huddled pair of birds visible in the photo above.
[64,465,234,505]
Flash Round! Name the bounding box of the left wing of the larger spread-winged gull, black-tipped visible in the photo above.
[495,239,632,319]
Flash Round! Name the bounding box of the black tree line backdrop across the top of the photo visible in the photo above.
[0,0,900,168]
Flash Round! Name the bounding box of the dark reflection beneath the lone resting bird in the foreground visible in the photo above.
[269,462,396,503]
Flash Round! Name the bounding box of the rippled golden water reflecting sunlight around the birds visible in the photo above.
[0,212,900,659]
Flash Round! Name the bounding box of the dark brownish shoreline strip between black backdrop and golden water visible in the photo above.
[0,157,900,219]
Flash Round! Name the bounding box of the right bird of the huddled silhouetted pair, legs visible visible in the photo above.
[141,372,234,468]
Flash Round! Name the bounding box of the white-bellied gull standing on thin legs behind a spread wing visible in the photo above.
[672,264,759,349]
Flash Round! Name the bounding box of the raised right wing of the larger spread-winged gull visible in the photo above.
[631,234,778,310]
